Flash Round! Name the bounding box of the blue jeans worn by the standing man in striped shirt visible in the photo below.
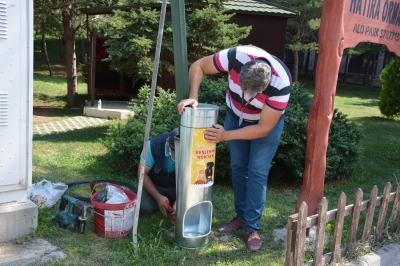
[224,112,284,231]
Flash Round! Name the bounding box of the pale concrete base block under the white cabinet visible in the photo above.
[0,199,38,242]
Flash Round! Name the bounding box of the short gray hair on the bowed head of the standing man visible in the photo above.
[240,59,271,97]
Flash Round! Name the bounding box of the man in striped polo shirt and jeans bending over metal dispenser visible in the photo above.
[178,45,292,251]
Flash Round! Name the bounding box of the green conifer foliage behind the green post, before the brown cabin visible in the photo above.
[105,0,251,81]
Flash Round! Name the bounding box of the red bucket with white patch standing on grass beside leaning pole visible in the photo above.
[90,182,136,238]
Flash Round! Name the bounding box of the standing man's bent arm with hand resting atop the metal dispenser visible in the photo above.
[178,55,218,114]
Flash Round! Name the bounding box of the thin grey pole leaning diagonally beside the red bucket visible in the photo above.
[132,0,167,255]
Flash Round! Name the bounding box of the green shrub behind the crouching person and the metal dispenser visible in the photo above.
[103,77,230,179]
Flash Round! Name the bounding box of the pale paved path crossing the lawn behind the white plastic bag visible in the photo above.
[33,116,110,138]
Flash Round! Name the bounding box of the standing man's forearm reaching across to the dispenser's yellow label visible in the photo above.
[204,105,282,143]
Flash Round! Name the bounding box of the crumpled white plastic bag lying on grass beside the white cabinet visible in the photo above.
[27,179,68,208]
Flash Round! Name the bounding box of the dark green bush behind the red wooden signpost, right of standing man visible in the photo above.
[270,83,361,183]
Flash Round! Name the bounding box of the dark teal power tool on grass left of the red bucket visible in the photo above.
[53,195,93,234]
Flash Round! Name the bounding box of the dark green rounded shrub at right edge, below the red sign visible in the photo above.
[378,57,400,118]
